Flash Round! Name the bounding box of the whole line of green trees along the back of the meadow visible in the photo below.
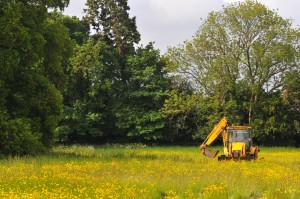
[0,0,300,155]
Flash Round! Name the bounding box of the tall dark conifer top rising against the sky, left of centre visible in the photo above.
[85,0,140,84]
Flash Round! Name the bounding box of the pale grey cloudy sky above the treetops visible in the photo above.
[64,0,300,53]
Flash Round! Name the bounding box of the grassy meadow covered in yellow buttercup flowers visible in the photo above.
[0,145,300,199]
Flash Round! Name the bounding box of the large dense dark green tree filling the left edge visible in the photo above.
[0,0,72,155]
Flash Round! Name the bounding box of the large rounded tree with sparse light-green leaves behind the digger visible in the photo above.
[169,0,300,123]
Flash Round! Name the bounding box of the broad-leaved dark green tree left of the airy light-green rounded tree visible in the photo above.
[115,43,170,140]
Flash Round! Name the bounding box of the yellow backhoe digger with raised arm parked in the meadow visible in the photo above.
[199,117,259,161]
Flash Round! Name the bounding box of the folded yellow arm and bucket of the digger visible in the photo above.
[199,117,228,158]
